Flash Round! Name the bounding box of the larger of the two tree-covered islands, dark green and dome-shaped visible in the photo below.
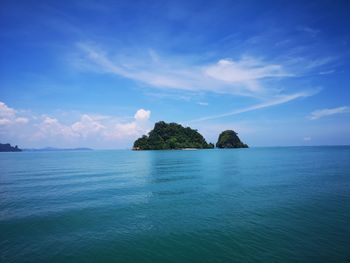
[133,121,214,150]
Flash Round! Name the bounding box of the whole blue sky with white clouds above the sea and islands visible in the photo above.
[0,0,350,149]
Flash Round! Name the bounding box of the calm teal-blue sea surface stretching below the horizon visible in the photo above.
[0,147,350,263]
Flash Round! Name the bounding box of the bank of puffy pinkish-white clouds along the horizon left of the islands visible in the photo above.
[0,103,151,148]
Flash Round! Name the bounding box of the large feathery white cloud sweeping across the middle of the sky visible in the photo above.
[78,43,293,97]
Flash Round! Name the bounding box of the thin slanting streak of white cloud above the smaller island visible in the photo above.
[190,90,319,122]
